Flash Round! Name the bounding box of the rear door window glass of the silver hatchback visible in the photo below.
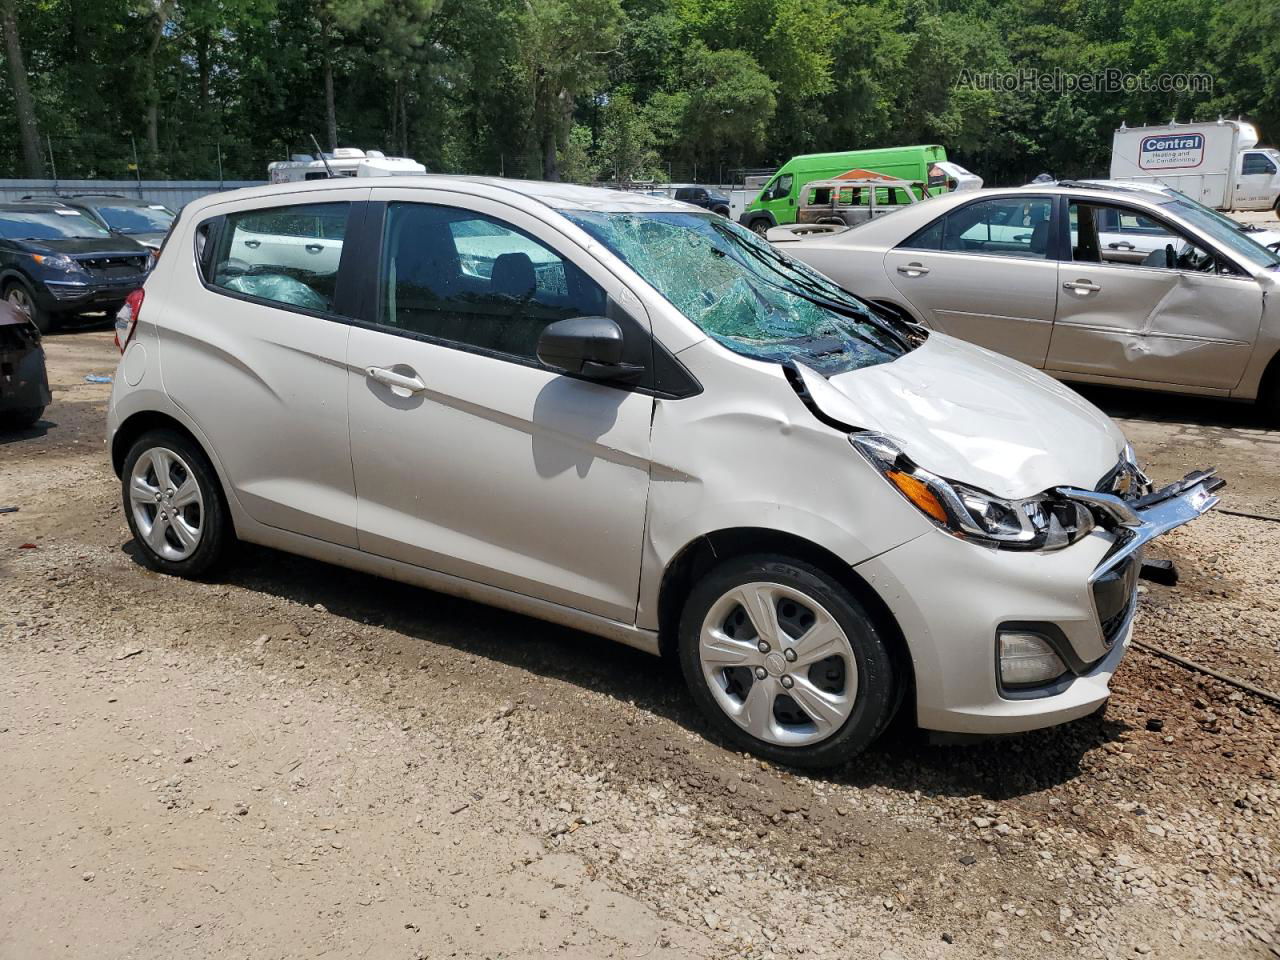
[211,204,351,312]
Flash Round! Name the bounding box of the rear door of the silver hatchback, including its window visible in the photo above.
[157,187,369,547]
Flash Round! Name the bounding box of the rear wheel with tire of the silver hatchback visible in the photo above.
[120,430,232,577]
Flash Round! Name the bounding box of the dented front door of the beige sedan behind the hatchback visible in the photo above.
[1047,202,1262,390]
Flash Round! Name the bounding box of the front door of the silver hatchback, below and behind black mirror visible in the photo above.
[348,193,654,623]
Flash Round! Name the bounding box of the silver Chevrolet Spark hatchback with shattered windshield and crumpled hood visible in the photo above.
[108,177,1221,767]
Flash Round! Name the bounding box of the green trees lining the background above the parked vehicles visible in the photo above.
[0,0,1280,183]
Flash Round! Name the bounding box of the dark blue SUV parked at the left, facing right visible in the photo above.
[0,201,154,333]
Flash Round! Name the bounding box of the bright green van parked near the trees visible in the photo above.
[739,143,947,236]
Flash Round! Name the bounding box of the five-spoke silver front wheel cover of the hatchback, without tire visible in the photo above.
[699,582,858,746]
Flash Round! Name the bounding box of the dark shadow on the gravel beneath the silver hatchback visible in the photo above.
[117,541,1125,800]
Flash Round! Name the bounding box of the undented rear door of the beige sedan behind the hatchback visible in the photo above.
[884,195,1059,366]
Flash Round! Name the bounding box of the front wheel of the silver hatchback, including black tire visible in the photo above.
[678,554,899,768]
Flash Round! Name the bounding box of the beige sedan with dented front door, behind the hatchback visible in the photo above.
[769,182,1280,417]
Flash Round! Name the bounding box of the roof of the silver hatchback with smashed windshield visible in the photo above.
[191,174,691,214]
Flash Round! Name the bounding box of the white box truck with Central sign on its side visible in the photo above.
[1111,120,1280,212]
